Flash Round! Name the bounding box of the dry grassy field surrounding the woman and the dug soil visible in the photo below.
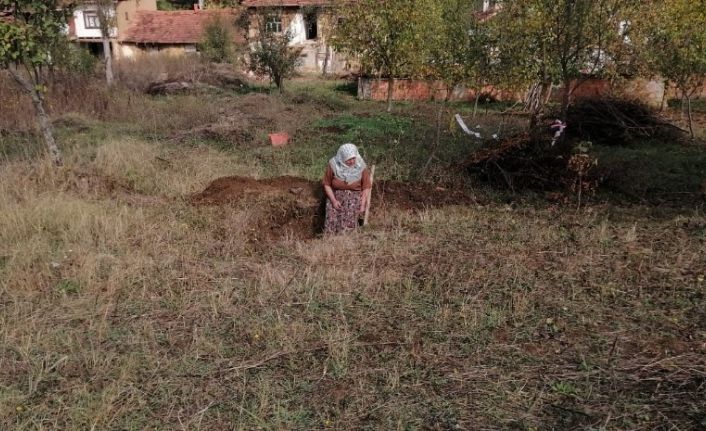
[0,76,706,431]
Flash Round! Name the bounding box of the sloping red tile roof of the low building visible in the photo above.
[119,9,245,45]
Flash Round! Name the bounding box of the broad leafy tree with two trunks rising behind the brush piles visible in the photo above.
[491,0,639,136]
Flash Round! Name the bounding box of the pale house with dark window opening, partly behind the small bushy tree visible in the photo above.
[241,0,350,74]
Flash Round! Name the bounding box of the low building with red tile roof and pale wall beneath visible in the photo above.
[118,6,245,58]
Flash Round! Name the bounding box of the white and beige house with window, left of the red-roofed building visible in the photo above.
[69,0,157,55]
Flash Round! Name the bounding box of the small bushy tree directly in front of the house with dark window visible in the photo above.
[248,8,302,93]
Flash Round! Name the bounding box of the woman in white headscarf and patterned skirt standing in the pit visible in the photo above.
[323,144,372,234]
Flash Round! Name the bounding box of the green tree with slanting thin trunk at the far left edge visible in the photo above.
[0,0,72,165]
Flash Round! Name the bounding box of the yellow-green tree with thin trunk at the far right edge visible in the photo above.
[636,0,706,138]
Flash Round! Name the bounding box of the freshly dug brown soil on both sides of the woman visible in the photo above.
[192,176,476,241]
